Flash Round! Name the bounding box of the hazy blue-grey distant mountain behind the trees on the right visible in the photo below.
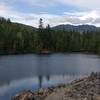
[52,24,99,32]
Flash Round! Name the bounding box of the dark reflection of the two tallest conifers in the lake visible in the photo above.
[37,55,50,88]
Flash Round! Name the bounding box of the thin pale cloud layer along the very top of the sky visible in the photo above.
[0,0,100,10]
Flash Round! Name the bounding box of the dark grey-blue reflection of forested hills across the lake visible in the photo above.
[0,54,100,84]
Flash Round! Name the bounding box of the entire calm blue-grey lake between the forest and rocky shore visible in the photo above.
[0,54,100,100]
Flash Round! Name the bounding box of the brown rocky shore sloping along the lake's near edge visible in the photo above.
[11,73,100,100]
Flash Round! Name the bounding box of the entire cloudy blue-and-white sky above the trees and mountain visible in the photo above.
[0,0,100,27]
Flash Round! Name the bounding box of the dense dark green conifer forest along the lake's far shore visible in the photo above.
[0,18,100,54]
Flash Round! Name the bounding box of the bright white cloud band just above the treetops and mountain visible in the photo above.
[0,2,100,27]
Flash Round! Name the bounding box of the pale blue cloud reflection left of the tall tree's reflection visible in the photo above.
[0,78,38,96]
